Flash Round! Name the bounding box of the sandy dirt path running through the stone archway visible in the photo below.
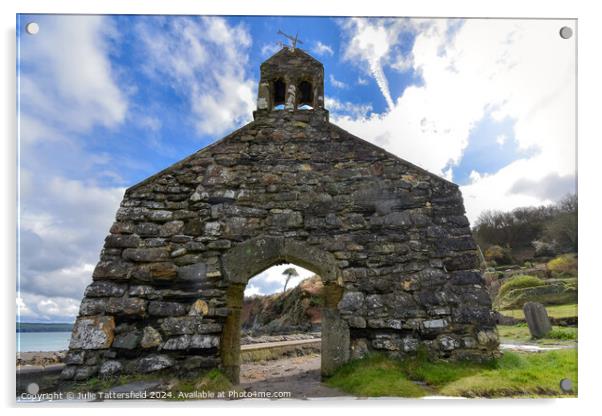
[240,354,347,399]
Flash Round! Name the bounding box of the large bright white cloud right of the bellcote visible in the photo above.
[334,19,575,220]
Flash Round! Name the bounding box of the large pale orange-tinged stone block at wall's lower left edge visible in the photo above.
[69,316,115,350]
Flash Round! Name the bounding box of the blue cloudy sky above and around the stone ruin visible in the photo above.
[17,15,576,321]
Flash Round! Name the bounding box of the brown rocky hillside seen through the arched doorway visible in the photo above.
[242,275,323,335]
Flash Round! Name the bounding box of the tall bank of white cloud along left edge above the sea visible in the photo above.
[17,15,130,320]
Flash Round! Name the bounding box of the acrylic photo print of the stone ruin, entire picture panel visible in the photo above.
[16,14,578,404]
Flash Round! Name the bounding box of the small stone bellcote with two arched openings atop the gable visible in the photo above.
[255,46,324,115]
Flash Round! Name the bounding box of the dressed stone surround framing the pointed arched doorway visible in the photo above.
[220,237,349,383]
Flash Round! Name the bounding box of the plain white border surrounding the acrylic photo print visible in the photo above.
[0,0,602,415]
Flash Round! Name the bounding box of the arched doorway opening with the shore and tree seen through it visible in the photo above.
[240,263,324,390]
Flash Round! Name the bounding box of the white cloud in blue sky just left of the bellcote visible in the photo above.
[137,17,256,135]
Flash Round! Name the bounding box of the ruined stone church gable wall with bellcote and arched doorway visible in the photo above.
[62,47,498,382]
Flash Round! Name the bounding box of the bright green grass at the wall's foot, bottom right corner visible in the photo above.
[326,349,577,397]
